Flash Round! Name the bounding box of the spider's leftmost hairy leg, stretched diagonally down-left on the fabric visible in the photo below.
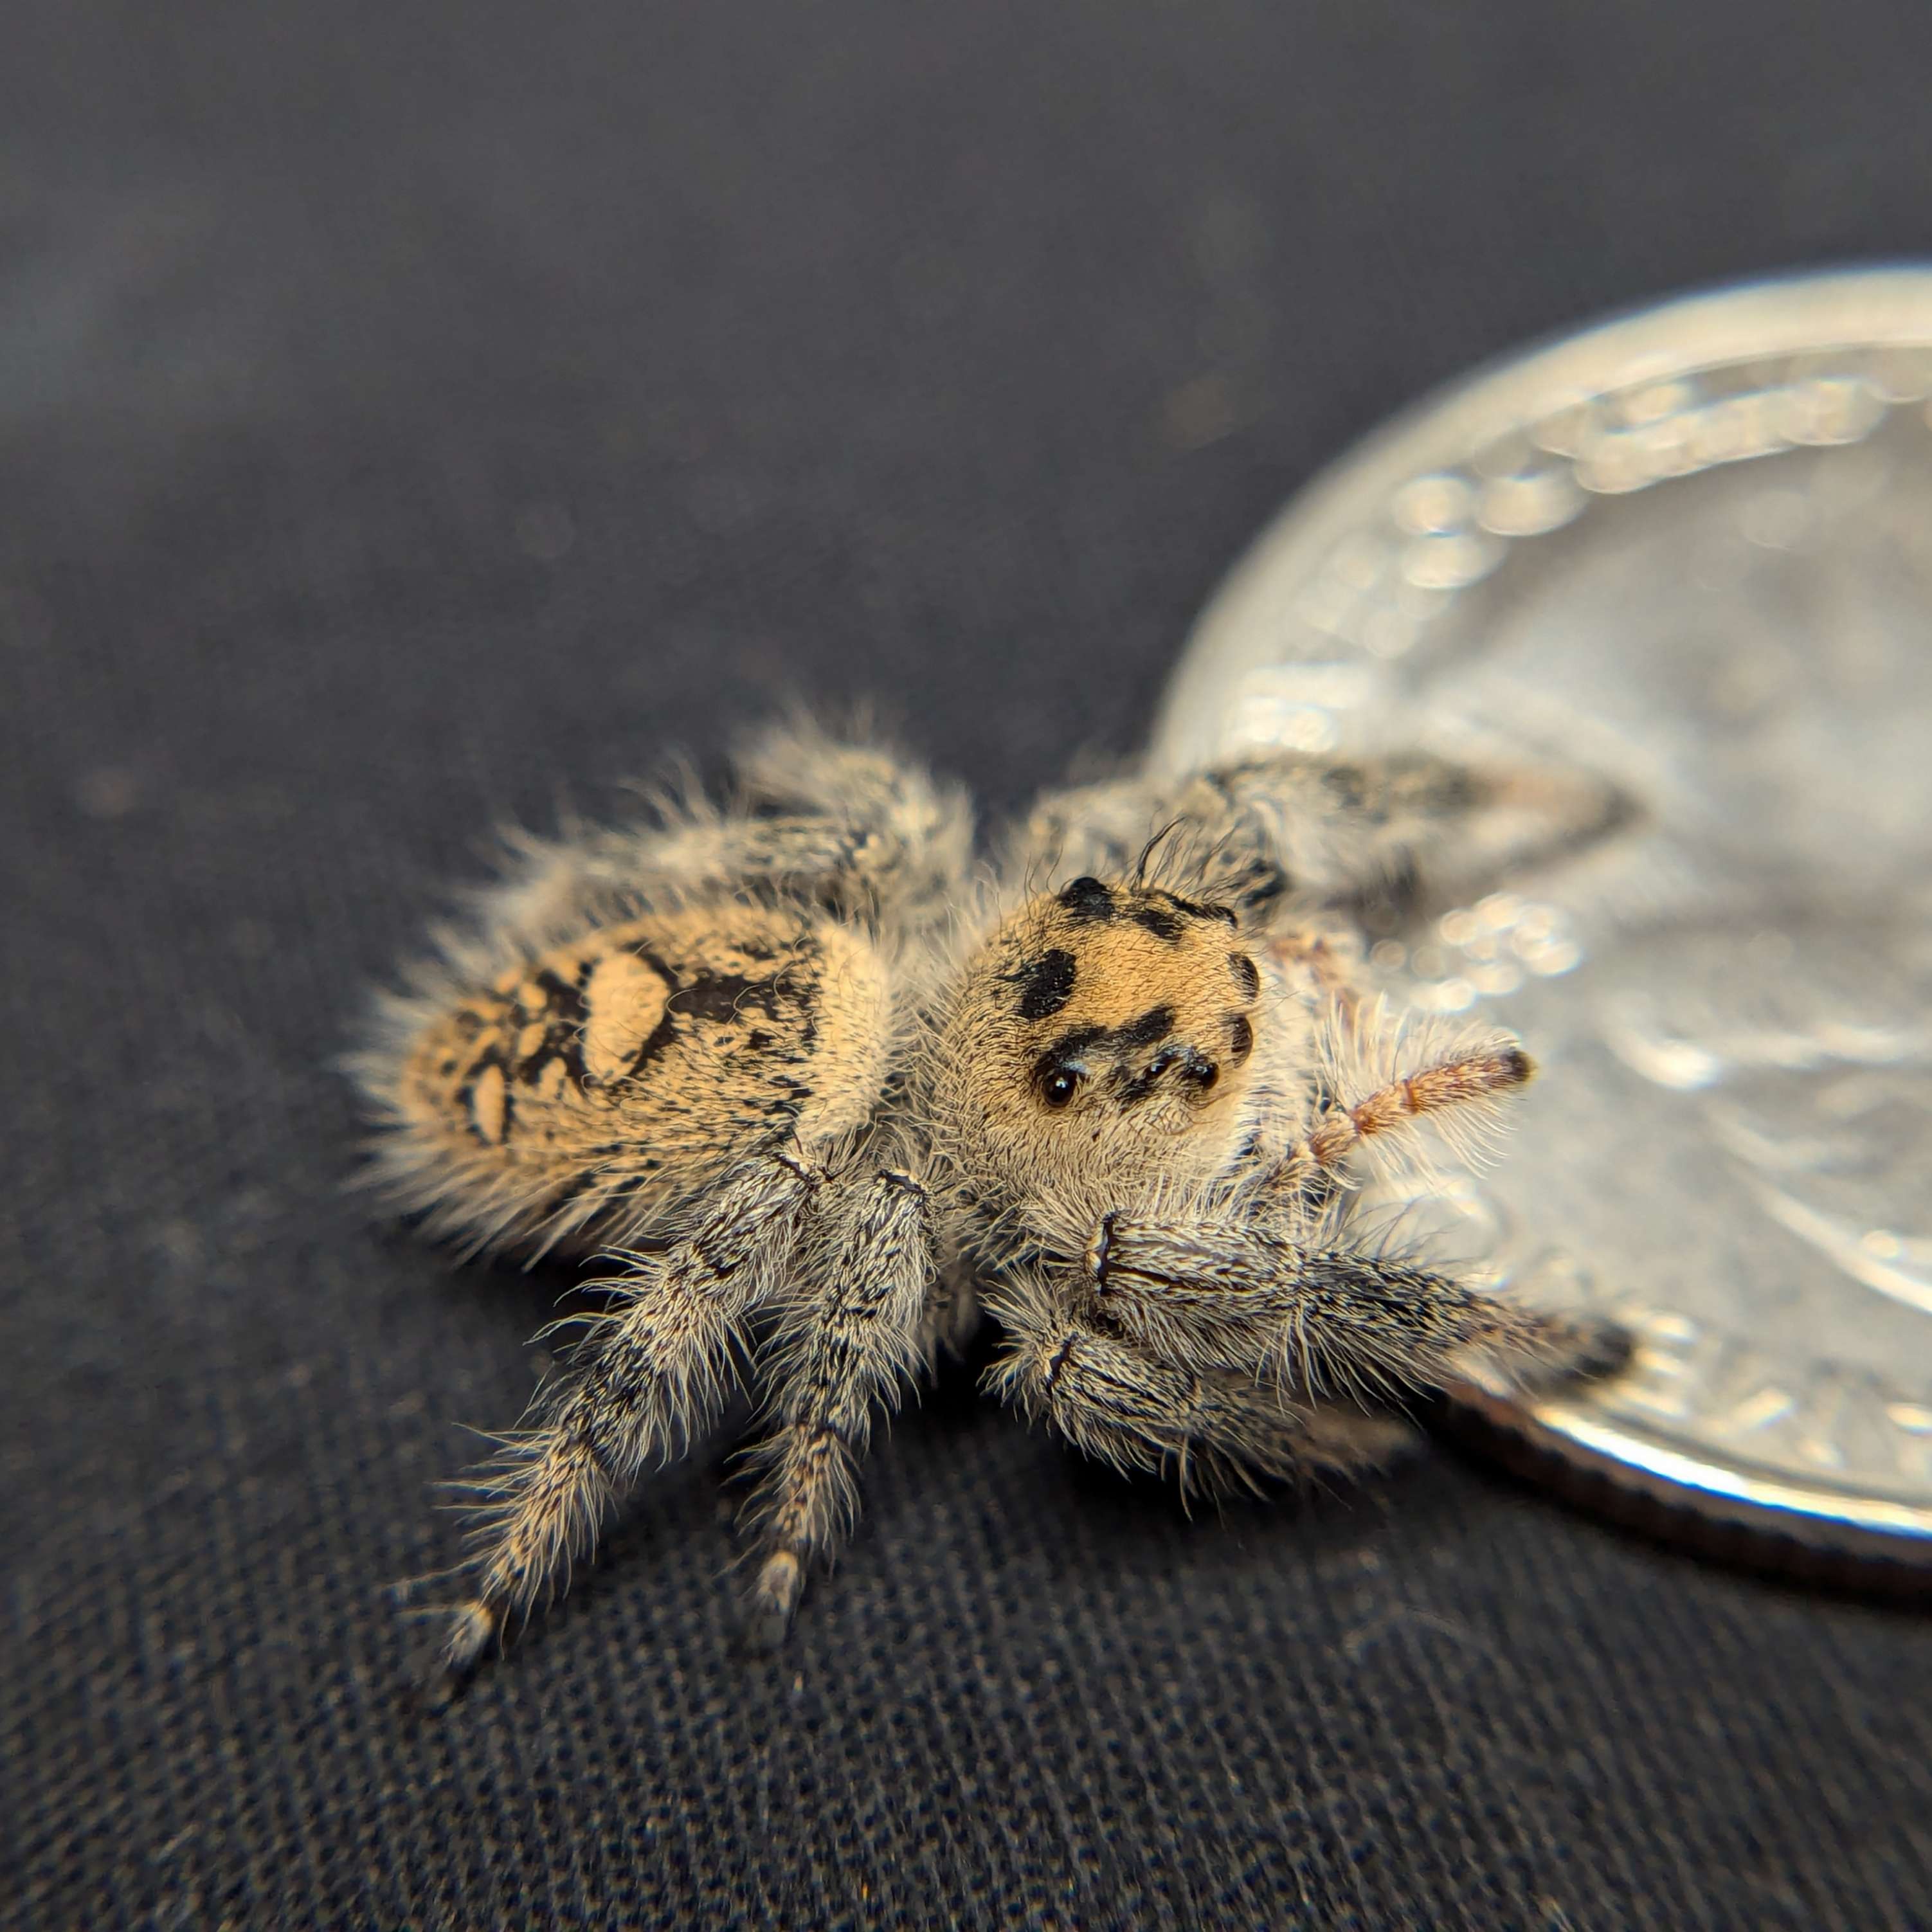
[438,1155,819,1683]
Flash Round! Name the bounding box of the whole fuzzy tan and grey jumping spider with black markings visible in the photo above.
[359,727,1621,1681]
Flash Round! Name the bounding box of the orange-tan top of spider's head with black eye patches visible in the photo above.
[941,879,1261,1192]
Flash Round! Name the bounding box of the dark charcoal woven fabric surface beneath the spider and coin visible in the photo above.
[0,0,1932,1932]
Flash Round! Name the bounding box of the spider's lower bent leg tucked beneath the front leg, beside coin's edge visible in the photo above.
[988,1275,1413,1495]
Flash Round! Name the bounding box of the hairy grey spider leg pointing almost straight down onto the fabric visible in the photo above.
[750,1171,935,1648]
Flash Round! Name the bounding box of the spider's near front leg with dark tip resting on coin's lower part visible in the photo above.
[1084,1215,1629,1395]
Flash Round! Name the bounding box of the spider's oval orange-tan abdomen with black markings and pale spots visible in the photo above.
[371,902,890,1240]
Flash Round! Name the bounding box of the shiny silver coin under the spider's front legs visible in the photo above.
[1151,271,1932,1575]
